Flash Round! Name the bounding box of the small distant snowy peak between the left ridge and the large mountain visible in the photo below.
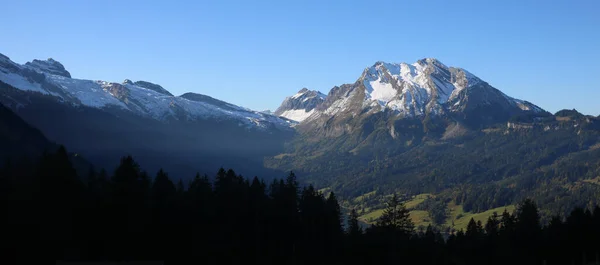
[274,88,327,122]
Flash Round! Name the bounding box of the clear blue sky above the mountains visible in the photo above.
[0,0,600,115]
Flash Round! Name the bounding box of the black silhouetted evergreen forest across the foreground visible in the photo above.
[0,147,600,264]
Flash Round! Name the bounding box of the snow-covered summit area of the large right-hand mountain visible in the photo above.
[358,58,520,116]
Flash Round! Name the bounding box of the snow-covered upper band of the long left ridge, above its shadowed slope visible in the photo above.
[0,52,290,129]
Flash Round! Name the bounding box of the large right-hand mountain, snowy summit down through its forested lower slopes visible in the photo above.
[265,58,600,223]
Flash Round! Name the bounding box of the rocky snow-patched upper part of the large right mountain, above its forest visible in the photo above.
[276,58,545,134]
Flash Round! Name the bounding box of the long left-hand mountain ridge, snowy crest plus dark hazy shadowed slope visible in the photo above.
[0,52,295,177]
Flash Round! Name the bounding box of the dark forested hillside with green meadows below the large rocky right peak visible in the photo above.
[266,110,600,229]
